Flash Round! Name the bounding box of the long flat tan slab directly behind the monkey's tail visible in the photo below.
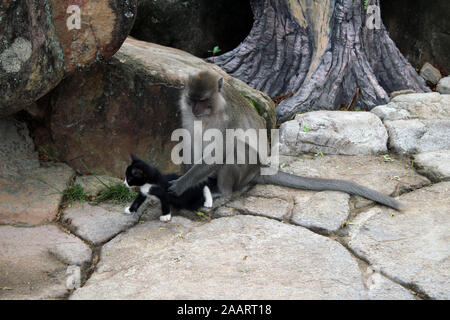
[283,155,430,208]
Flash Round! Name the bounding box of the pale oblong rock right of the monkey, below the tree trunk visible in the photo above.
[280,111,388,155]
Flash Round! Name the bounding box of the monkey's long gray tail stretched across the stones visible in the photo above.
[255,171,404,210]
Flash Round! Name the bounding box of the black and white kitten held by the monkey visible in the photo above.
[124,154,216,222]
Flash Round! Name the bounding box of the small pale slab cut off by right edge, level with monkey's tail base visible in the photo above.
[414,150,450,182]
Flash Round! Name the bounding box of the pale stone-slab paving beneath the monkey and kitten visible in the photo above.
[0,94,450,300]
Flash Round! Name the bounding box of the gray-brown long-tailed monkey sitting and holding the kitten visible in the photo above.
[169,71,403,210]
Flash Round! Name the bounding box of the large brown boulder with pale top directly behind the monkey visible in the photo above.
[43,38,275,177]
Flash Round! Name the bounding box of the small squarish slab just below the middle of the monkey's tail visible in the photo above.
[292,191,350,233]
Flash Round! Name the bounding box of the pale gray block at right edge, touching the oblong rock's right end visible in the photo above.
[385,118,450,155]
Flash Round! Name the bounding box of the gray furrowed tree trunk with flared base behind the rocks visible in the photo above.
[209,0,429,122]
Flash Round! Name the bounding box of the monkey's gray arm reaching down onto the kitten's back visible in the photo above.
[169,163,221,196]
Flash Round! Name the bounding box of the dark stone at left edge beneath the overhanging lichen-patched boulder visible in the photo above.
[0,117,39,178]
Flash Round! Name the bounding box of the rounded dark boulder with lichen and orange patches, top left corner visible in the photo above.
[0,0,136,116]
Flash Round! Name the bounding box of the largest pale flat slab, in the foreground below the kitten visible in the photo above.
[71,215,368,300]
